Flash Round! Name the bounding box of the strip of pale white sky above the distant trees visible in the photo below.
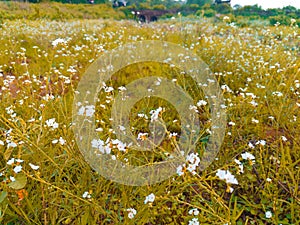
[231,0,300,9]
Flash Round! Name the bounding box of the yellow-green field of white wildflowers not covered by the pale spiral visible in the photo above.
[0,2,300,225]
